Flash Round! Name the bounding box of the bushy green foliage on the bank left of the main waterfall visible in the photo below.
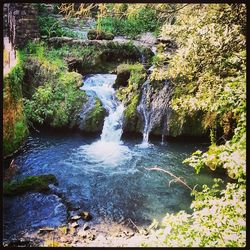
[24,43,85,127]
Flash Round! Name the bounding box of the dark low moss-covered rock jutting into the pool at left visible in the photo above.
[3,174,58,196]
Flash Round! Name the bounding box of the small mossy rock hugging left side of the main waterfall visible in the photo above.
[84,98,106,132]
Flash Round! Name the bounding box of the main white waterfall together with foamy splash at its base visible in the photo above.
[81,74,131,163]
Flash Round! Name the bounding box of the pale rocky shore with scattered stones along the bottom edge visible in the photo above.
[4,220,152,247]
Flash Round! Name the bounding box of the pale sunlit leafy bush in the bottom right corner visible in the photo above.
[143,180,246,247]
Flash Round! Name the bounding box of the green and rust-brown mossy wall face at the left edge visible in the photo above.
[3,51,28,156]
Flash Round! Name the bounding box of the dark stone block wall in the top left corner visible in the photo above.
[4,3,39,48]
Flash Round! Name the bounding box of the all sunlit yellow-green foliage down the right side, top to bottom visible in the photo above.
[145,4,246,247]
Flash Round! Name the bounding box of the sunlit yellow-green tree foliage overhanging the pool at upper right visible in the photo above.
[151,4,246,143]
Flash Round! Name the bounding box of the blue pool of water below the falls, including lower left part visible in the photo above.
[4,132,226,237]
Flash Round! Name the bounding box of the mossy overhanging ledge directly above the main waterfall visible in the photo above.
[50,41,141,75]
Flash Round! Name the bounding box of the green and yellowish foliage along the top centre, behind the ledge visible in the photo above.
[60,3,163,38]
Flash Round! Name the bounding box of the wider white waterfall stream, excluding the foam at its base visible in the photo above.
[81,74,124,142]
